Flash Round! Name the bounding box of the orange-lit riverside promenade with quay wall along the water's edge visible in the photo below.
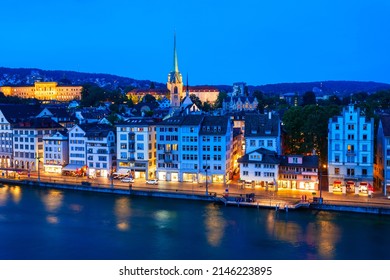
[0,176,390,215]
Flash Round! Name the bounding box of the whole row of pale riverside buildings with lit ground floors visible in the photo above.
[0,100,390,193]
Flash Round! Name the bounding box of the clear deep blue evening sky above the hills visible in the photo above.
[0,0,390,85]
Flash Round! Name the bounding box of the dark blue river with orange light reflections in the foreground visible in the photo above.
[0,186,390,259]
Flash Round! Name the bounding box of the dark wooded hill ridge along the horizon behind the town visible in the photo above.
[0,67,390,96]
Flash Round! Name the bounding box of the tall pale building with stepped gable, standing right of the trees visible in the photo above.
[328,105,374,194]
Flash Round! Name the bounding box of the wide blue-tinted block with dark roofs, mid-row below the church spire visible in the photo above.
[157,115,233,183]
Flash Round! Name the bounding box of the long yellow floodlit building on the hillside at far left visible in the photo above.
[0,82,83,102]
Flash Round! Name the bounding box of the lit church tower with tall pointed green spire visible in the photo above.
[167,33,183,109]
